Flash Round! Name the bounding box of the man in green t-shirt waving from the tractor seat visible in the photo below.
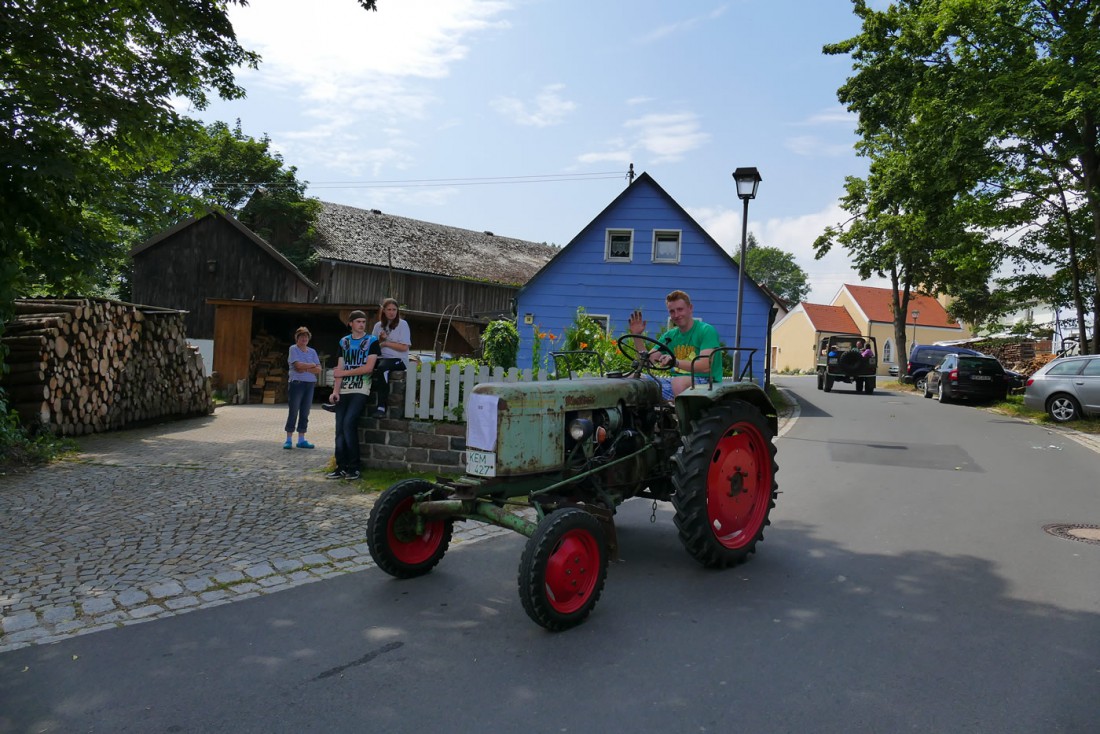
[628,291,722,399]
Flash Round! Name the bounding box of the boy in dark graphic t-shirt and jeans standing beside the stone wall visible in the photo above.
[327,310,382,481]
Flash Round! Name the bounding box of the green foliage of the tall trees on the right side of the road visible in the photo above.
[820,0,1100,350]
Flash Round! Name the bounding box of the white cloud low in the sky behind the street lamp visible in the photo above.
[689,204,890,304]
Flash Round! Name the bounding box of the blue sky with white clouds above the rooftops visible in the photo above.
[189,0,887,303]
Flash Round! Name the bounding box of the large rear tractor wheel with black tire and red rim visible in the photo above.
[672,402,778,568]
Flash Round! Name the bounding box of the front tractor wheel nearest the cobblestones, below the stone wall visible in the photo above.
[366,479,454,579]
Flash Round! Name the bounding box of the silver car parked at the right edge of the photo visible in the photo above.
[1024,354,1100,423]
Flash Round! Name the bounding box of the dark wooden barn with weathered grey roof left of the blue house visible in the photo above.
[131,202,556,383]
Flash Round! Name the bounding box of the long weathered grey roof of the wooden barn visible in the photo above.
[314,201,557,285]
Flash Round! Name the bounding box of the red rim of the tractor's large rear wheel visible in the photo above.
[706,423,771,550]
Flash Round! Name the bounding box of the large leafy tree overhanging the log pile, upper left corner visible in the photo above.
[0,0,376,387]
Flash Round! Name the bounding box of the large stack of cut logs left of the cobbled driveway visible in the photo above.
[0,298,213,436]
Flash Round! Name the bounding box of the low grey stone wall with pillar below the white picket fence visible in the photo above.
[359,372,466,474]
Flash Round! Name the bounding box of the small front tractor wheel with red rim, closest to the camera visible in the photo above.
[519,507,607,632]
